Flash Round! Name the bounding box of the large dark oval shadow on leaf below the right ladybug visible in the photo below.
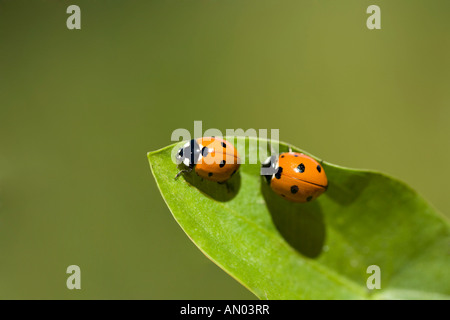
[261,179,325,258]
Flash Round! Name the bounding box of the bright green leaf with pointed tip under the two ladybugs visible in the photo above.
[148,137,450,299]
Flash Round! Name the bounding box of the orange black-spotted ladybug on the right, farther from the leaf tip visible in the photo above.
[261,151,328,202]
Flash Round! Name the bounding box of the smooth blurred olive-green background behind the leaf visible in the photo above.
[0,0,450,299]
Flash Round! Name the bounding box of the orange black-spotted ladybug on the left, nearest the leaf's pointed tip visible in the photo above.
[175,137,240,183]
